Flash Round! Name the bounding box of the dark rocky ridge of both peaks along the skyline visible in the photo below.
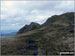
[17,12,74,34]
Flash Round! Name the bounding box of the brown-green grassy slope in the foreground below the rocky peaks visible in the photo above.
[2,24,73,55]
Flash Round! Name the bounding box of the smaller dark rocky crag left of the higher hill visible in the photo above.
[17,22,40,34]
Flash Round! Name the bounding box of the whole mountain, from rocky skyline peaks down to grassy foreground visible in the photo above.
[1,12,74,55]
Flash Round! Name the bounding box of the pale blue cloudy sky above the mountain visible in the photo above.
[0,0,74,31]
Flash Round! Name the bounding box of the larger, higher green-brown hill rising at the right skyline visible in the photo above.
[43,12,74,26]
